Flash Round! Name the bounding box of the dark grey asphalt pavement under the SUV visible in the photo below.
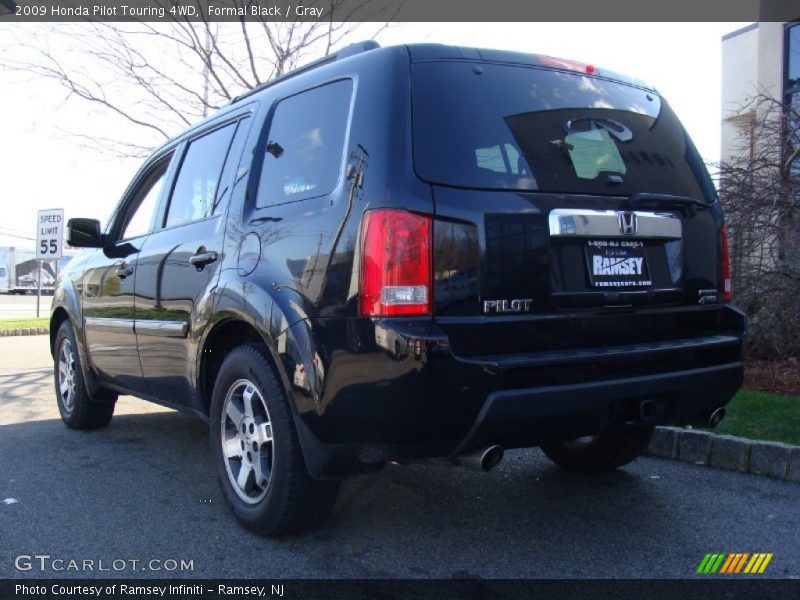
[0,336,800,578]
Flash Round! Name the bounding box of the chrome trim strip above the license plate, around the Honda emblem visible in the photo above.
[548,208,683,240]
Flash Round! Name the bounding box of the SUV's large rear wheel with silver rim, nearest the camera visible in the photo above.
[210,344,339,537]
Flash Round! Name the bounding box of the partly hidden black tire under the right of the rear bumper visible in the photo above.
[542,427,653,473]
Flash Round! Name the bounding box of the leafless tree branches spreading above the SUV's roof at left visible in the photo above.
[0,0,388,157]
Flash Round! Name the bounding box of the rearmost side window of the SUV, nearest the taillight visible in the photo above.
[256,79,353,208]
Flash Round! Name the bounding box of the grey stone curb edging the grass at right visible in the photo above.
[647,427,800,483]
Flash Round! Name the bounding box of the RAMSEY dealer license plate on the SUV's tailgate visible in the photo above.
[586,240,653,287]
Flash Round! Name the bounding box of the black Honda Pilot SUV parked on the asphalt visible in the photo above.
[50,43,744,535]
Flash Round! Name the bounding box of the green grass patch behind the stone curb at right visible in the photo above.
[712,390,800,446]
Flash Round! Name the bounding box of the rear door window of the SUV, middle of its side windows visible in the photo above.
[164,123,236,227]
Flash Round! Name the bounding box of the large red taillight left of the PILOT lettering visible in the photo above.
[358,209,432,317]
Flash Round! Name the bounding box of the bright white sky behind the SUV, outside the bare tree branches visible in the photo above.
[0,23,746,248]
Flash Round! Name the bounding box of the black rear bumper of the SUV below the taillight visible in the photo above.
[286,307,744,478]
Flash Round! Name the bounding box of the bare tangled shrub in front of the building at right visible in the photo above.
[719,95,800,358]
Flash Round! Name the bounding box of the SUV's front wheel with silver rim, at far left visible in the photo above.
[53,320,117,429]
